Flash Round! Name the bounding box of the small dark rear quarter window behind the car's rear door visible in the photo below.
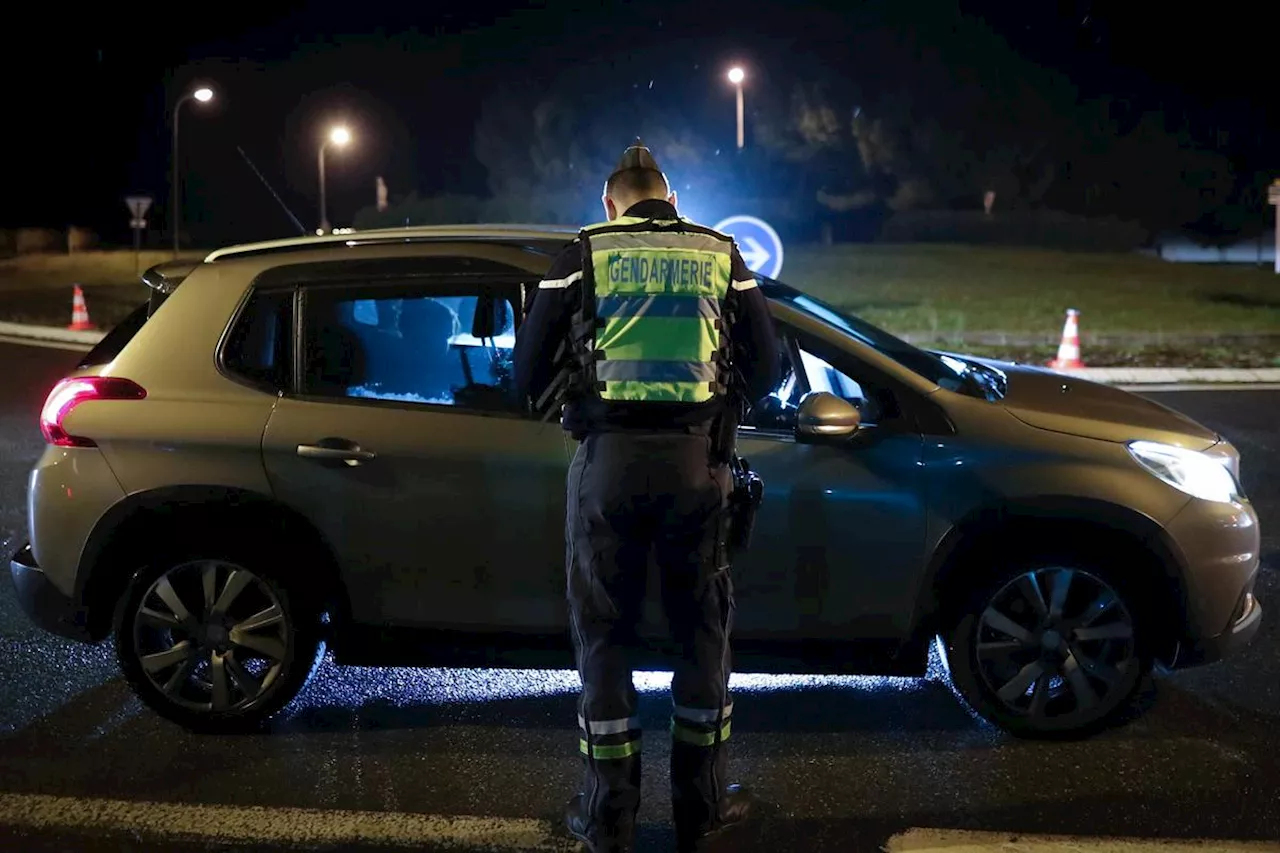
[221,291,293,391]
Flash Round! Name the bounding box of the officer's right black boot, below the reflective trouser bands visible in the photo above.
[671,742,751,853]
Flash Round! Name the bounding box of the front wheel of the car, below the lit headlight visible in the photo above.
[940,560,1153,739]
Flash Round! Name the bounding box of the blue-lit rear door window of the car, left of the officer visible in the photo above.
[303,284,520,411]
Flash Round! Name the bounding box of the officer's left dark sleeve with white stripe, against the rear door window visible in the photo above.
[512,241,582,401]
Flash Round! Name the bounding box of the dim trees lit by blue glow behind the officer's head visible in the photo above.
[356,9,1268,241]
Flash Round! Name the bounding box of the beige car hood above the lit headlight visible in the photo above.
[968,357,1221,451]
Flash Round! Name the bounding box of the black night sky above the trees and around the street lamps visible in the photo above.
[0,0,1280,242]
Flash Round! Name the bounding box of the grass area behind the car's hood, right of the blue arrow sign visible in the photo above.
[781,245,1280,343]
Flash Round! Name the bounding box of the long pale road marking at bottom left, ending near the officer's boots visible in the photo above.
[0,794,580,853]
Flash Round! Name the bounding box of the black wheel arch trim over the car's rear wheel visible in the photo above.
[76,485,349,640]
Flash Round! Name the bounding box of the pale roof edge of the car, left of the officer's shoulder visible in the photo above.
[205,224,579,263]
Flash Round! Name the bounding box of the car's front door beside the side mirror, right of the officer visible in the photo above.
[733,324,927,640]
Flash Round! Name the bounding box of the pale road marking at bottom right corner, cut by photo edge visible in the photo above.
[884,829,1280,853]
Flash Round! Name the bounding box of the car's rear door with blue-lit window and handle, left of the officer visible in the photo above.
[264,259,568,633]
